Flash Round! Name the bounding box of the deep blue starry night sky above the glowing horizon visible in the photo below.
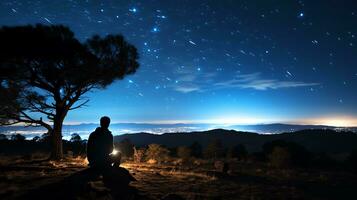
[0,0,357,125]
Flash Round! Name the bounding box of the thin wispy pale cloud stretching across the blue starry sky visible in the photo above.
[172,73,320,93]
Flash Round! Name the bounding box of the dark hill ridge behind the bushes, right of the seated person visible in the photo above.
[114,129,357,153]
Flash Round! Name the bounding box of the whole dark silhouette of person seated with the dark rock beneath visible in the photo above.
[87,116,135,185]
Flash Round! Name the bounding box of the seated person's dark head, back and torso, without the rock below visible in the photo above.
[87,117,113,167]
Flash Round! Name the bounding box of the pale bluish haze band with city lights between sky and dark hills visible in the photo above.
[0,123,357,140]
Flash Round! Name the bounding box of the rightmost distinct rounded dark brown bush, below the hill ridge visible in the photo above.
[268,146,291,168]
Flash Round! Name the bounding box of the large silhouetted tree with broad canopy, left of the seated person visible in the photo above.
[0,25,139,159]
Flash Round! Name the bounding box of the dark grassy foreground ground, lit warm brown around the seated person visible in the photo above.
[0,157,357,200]
